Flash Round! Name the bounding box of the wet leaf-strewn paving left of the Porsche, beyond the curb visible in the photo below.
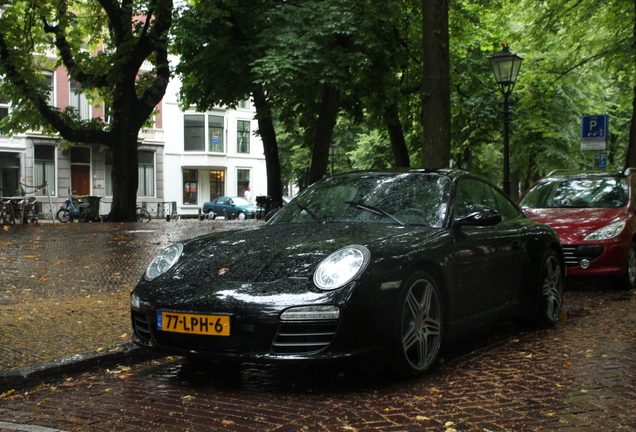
[0,220,253,374]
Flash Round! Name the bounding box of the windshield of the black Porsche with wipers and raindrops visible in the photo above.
[271,173,450,227]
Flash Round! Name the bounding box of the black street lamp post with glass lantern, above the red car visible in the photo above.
[488,43,523,195]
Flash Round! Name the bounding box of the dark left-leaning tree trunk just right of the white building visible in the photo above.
[253,90,283,208]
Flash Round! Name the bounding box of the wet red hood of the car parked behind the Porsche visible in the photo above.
[523,207,627,244]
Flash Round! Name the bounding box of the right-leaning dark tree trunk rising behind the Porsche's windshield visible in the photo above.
[309,86,340,184]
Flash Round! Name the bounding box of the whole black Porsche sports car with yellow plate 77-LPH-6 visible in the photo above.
[131,170,565,375]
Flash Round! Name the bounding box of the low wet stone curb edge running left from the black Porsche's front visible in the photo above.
[0,342,163,394]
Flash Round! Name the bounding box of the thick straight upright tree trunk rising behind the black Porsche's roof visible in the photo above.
[421,0,451,168]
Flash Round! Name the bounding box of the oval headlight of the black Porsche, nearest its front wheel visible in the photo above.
[314,245,371,290]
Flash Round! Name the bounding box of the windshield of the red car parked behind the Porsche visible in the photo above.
[519,177,627,208]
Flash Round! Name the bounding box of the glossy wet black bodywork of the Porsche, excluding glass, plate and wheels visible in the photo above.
[132,171,563,373]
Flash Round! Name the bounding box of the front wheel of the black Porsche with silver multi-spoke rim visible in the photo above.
[393,272,444,377]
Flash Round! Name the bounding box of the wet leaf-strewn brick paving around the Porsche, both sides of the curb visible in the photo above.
[0,221,636,432]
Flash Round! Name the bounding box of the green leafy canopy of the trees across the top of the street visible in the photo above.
[6,0,636,194]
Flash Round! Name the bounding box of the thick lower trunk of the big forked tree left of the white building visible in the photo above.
[107,135,139,222]
